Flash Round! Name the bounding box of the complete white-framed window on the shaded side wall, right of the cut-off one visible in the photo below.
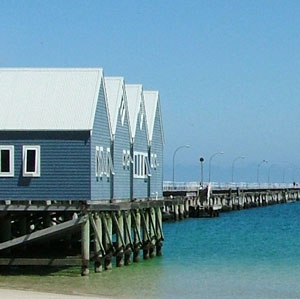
[23,145,41,177]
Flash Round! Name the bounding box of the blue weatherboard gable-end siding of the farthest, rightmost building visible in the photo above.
[150,108,163,197]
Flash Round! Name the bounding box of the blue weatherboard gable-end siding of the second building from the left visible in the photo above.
[113,109,130,200]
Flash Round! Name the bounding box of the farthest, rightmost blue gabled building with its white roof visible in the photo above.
[143,91,164,198]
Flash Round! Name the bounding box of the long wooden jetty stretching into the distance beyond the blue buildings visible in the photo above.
[164,185,300,220]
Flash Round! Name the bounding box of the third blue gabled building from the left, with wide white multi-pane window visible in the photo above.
[125,84,151,199]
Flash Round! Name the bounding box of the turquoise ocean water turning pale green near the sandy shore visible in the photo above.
[0,202,300,298]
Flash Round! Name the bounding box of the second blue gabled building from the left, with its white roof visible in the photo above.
[105,77,132,200]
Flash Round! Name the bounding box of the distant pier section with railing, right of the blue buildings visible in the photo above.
[163,182,300,218]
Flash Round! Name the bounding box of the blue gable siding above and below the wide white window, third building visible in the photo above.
[133,111,148,198]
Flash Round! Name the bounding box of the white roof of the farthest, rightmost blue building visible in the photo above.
[143,90,164,143]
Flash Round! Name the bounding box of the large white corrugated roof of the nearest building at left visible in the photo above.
[0,68,103,131]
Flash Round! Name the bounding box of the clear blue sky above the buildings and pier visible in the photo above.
[0,0,300,181]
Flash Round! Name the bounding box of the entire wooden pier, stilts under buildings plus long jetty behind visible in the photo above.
[0,184,300,275]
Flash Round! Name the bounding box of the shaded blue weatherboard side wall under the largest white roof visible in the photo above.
[0,131,90,200]
